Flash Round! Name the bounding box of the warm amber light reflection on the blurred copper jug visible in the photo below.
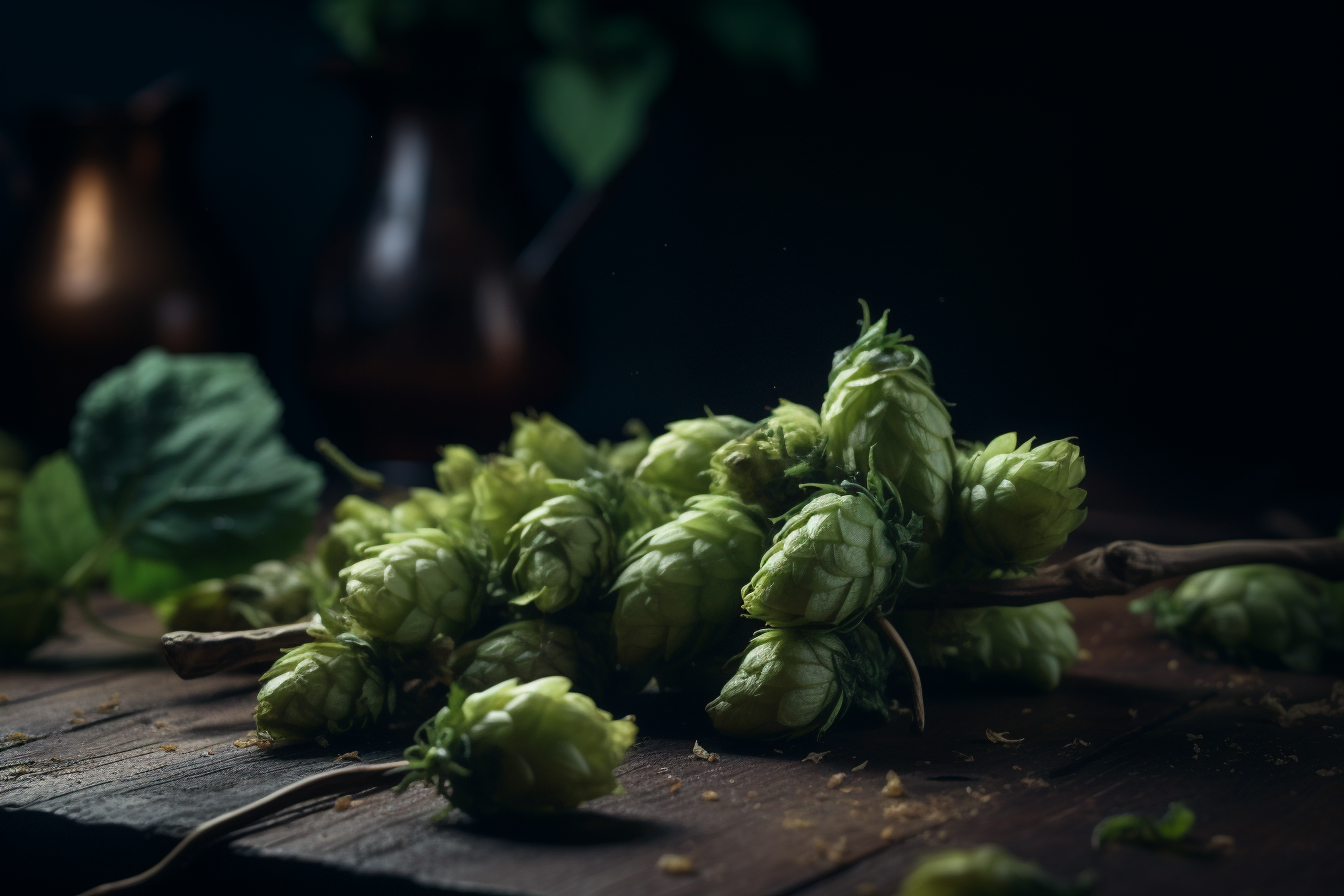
[55,164,112,305]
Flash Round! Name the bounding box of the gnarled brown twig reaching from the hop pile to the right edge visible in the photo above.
[898,539,1344,610]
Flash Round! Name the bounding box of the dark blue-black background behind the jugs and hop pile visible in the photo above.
[0,0,1344,537]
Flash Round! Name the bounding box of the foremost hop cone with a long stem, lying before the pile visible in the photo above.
[401,676,637,818]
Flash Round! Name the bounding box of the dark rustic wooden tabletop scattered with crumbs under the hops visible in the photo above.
[0,598,1344,896]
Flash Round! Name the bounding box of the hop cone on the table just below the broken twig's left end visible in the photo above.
[257,635,387,740]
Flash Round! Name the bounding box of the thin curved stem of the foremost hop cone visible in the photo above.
[81,759,406,896]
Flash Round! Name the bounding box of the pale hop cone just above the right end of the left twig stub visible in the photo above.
[341,529,485,647]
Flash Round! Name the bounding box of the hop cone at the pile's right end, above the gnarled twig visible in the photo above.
[957,433,1087,571]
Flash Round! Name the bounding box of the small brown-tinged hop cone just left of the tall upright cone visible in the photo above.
[710,399,825,516]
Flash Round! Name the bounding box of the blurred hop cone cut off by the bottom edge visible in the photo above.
[896,845,1087,896]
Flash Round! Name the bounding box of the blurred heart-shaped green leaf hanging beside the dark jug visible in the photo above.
[528,19,672,189]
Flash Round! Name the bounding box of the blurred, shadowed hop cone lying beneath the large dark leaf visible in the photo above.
[161,560,313,631]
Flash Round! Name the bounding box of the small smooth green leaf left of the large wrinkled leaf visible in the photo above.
[19,451,101,582]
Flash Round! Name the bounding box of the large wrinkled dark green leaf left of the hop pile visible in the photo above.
[70,349,321,578]
